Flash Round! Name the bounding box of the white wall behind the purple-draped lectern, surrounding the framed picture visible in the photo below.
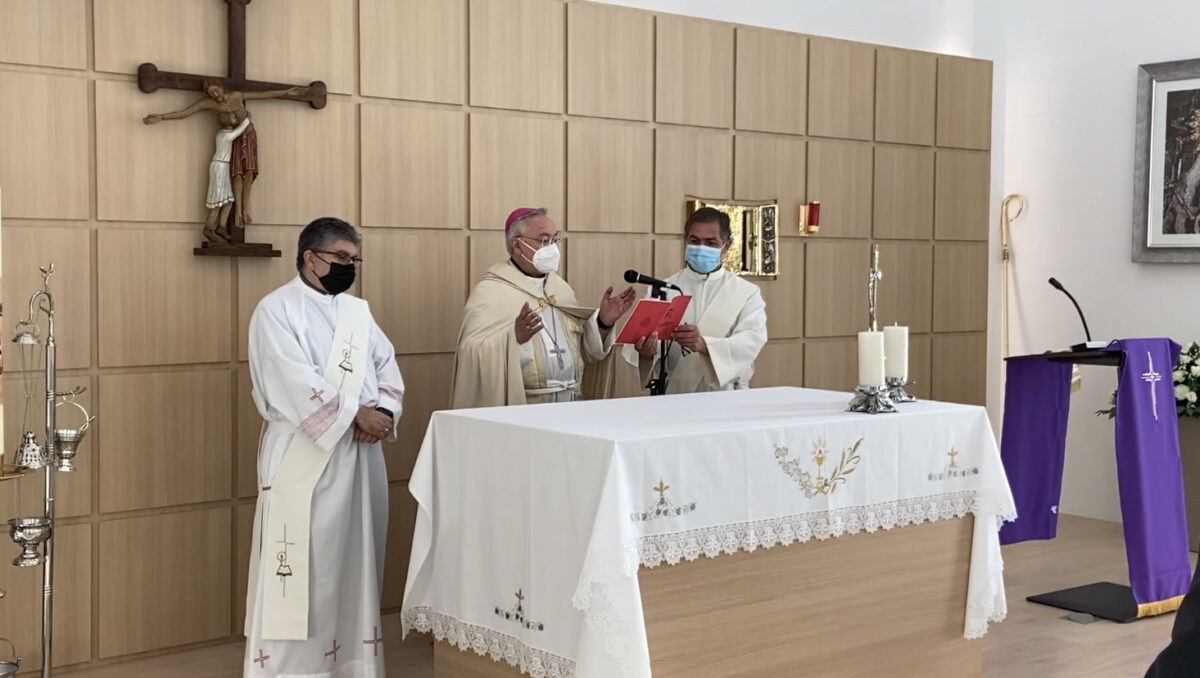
[978,0,1200,521]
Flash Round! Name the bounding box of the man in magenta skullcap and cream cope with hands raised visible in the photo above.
[450,208,636,408]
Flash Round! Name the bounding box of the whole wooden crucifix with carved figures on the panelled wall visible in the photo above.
[138,0,325,257]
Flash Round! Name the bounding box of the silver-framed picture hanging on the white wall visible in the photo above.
[1132,59,1200,263]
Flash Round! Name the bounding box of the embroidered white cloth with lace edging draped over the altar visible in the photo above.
[403,388,1015,678]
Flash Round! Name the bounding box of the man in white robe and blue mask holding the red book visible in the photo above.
[622,208,767,394]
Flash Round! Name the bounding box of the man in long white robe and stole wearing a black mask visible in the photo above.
[244,217,404,678]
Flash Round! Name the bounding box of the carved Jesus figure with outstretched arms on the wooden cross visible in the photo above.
[142,80,307,228]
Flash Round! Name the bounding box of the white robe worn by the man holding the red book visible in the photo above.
[622,268,767,394]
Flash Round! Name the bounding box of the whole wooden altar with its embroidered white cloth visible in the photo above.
[403,388,1014,678]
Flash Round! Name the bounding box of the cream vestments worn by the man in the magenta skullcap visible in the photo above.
[450,262,616,409]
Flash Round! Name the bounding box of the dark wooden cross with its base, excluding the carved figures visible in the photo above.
[138,0,326,257]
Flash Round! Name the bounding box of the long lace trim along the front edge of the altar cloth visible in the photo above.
[637,490,993,568]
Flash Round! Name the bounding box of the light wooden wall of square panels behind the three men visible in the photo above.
[0,0,991,667]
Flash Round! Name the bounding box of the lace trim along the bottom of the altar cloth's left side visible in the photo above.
[404,606,575,678]
